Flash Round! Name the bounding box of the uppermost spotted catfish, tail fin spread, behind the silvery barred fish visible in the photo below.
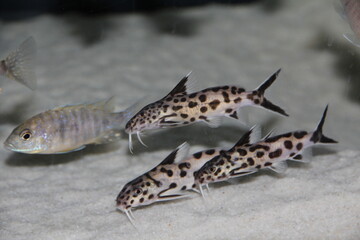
[125,69,288,150]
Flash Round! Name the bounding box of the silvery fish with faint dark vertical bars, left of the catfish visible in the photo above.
[4,98,133,154]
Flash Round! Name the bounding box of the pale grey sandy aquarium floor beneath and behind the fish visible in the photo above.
[0,0,360,240]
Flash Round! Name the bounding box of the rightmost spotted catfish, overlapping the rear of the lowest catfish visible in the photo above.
[194,107,337,192]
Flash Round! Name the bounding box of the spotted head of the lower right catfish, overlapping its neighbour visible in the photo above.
[194,155,227,185]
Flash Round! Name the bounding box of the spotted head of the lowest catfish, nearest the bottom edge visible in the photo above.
[116,176,158,212]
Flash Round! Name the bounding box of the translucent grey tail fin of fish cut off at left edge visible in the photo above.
[4,37,36,90]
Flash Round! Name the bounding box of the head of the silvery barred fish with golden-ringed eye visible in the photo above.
[4,119,48,153]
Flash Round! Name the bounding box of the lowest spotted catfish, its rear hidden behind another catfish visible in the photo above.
[116,143,219,221]
